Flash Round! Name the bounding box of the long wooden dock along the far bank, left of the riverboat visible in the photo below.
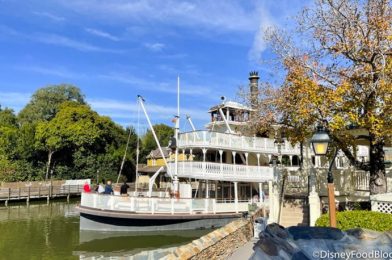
[0,184,83,206]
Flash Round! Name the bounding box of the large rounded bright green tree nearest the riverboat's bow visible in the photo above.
[35,102,137,179]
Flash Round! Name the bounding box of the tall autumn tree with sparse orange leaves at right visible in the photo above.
[253,0,392,194]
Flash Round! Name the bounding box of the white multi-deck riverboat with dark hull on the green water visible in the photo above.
[79,72,300,231]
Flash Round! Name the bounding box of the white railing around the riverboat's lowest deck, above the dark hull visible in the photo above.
[80,193,262,214]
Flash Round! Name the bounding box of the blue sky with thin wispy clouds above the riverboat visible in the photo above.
[0,0,304,130]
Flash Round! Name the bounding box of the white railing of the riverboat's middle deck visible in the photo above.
[168,161,274,182]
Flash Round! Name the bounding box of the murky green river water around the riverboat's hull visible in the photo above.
[0,201,210,259]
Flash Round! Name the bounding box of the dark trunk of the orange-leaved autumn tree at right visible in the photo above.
[369,142,387,194]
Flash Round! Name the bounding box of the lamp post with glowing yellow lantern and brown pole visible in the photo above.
[310,126,338,227]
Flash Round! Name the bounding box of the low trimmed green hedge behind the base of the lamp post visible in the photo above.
[316,210,392,232]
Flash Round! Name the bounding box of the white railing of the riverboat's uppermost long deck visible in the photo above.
[178,130,300,155]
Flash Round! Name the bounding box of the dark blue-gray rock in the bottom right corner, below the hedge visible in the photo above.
[251,224,392,260]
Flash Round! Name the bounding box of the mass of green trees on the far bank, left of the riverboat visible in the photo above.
[0,85,138,181]
